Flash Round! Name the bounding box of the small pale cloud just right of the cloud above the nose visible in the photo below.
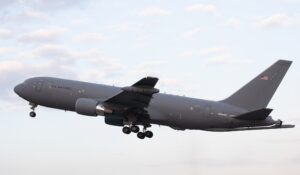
[74,33,108,43]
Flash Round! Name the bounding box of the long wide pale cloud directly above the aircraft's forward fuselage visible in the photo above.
[27,44,124,74]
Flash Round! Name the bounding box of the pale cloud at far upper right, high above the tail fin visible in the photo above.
[256,13,299,28]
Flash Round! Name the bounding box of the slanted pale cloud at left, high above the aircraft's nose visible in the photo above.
[18,27,67,43]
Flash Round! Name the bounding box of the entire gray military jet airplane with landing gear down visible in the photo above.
[14,60,294,139]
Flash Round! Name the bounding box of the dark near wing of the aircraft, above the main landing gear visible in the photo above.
[104,77,159,109]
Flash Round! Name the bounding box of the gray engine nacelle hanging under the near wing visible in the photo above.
[75,98,113,116]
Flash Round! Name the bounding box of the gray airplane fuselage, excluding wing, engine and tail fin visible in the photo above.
[16,77,275,130]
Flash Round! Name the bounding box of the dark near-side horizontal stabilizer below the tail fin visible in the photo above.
[235,108,273,120]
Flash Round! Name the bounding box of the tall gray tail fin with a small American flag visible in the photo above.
[221,60,292,111]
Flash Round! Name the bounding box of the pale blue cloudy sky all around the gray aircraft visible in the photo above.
[0,0,300,175]
